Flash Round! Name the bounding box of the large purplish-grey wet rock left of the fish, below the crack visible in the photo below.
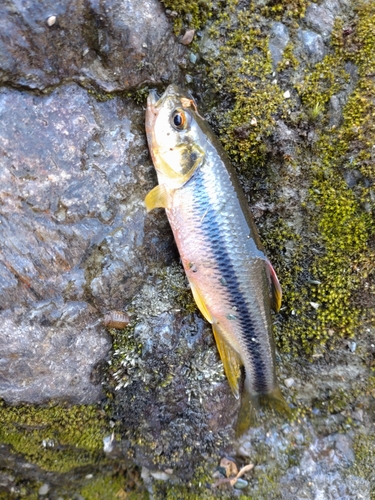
[0,84,171,403]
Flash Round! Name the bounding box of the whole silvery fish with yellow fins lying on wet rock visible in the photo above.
[145,84,290,436]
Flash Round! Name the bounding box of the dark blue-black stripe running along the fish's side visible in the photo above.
[191,172,272,393]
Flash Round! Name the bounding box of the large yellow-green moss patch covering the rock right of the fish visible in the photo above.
[198,2,375,354]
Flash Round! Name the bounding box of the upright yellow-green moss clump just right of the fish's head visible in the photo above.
[209,7,285,169]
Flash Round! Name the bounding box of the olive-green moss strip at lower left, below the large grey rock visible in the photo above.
[0,402,105,472]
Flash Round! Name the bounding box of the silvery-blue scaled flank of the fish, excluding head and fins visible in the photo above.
[167,150,276,393]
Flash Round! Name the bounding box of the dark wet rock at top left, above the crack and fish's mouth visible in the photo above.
[0,0,184,92]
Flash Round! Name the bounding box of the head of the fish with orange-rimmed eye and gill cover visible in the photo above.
[146,85,207,188]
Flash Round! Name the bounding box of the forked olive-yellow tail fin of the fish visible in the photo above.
[235,386,292,438]
